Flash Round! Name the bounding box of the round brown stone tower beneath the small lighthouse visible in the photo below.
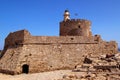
[60,19,92,36]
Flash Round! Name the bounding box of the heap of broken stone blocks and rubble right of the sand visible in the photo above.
[58,53,120,80]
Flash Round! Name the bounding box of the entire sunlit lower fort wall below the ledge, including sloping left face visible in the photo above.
[0,41,115,74]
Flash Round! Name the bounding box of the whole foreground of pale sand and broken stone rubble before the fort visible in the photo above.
[0,53,120,80]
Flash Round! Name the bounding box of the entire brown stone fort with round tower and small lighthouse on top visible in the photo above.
[0,10,118,74]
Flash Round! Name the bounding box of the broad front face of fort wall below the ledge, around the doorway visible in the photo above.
[17,44,99,73]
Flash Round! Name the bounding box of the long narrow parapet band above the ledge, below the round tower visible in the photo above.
[24,36,98,44]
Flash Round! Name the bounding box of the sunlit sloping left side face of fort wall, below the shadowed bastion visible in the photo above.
[0,47,22,74]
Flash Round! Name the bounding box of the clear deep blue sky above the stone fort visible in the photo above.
[0,0,120,49]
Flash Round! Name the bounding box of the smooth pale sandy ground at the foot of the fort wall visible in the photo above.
[0,70,72,80]
